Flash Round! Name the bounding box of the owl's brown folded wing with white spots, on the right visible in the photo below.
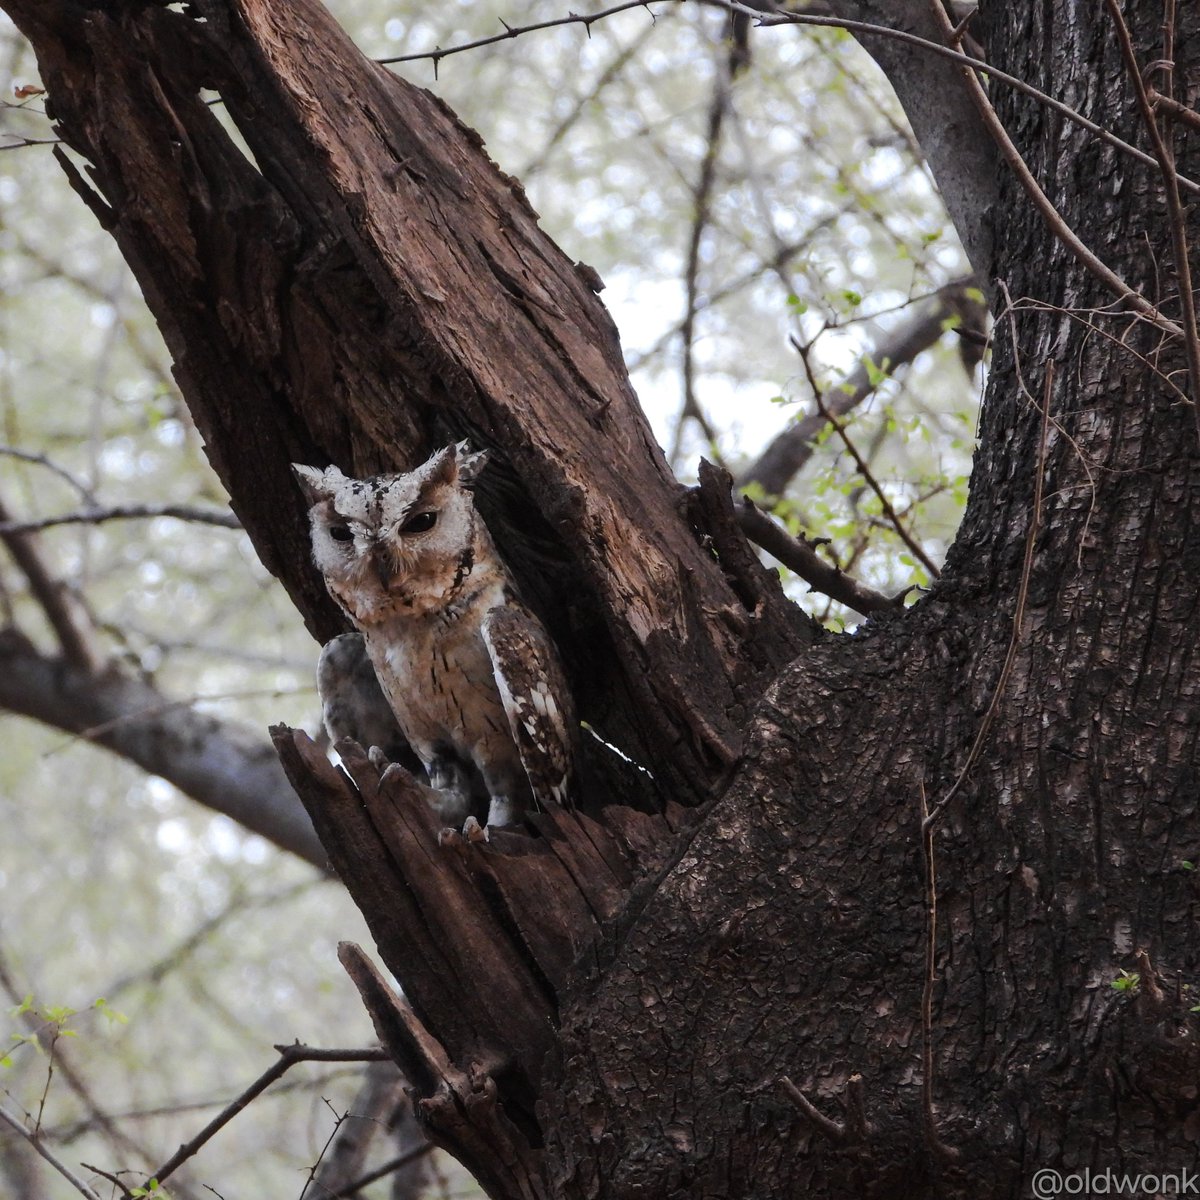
[481,604,575,804]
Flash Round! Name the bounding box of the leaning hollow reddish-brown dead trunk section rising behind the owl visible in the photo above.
[6,0,805,798]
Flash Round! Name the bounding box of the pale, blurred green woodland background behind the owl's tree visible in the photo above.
[0,0,982,1200]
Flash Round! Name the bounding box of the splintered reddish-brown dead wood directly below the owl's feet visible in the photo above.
[271,726,683,1099]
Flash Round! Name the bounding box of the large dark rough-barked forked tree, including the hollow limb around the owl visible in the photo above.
[9,0,1200,1198]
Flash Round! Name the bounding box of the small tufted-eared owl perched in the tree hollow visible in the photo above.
[293,442,577,826]
